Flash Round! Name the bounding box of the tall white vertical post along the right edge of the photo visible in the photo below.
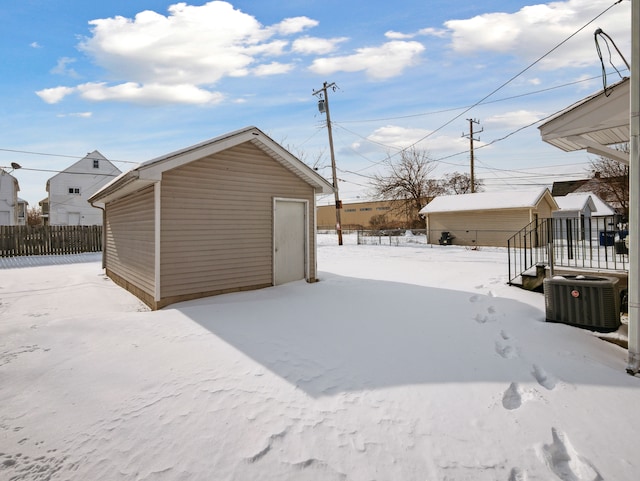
[627,0,640,375]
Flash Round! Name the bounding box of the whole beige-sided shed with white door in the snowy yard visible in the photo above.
[89,127,333,309]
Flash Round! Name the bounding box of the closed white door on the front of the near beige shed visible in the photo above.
[273,199,307,285]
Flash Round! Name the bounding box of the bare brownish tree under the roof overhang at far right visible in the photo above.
[591,144,629,218]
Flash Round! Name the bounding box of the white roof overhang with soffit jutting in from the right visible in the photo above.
[538,78,630,165]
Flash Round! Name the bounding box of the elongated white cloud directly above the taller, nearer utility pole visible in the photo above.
[309,40,424,80]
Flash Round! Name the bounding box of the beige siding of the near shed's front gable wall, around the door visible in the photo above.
[160,143,315,299]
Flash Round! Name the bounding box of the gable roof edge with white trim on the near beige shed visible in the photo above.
[89,127,333,203]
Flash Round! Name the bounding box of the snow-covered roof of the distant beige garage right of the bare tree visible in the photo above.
[420,187,557,214]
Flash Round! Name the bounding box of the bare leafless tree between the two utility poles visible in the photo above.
[370,147,443,225]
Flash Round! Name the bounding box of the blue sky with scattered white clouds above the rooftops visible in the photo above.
[0,0,631,205]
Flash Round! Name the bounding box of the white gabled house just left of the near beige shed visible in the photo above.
[43,150,121,225]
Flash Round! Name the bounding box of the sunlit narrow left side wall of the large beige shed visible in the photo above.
[105,186,155,299]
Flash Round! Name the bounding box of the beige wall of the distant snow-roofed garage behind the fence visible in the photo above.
[428,209,530,247]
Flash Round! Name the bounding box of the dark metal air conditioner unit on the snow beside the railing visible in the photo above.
[543,276,620,331]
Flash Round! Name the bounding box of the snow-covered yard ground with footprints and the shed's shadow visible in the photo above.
[0,236,640,481]
